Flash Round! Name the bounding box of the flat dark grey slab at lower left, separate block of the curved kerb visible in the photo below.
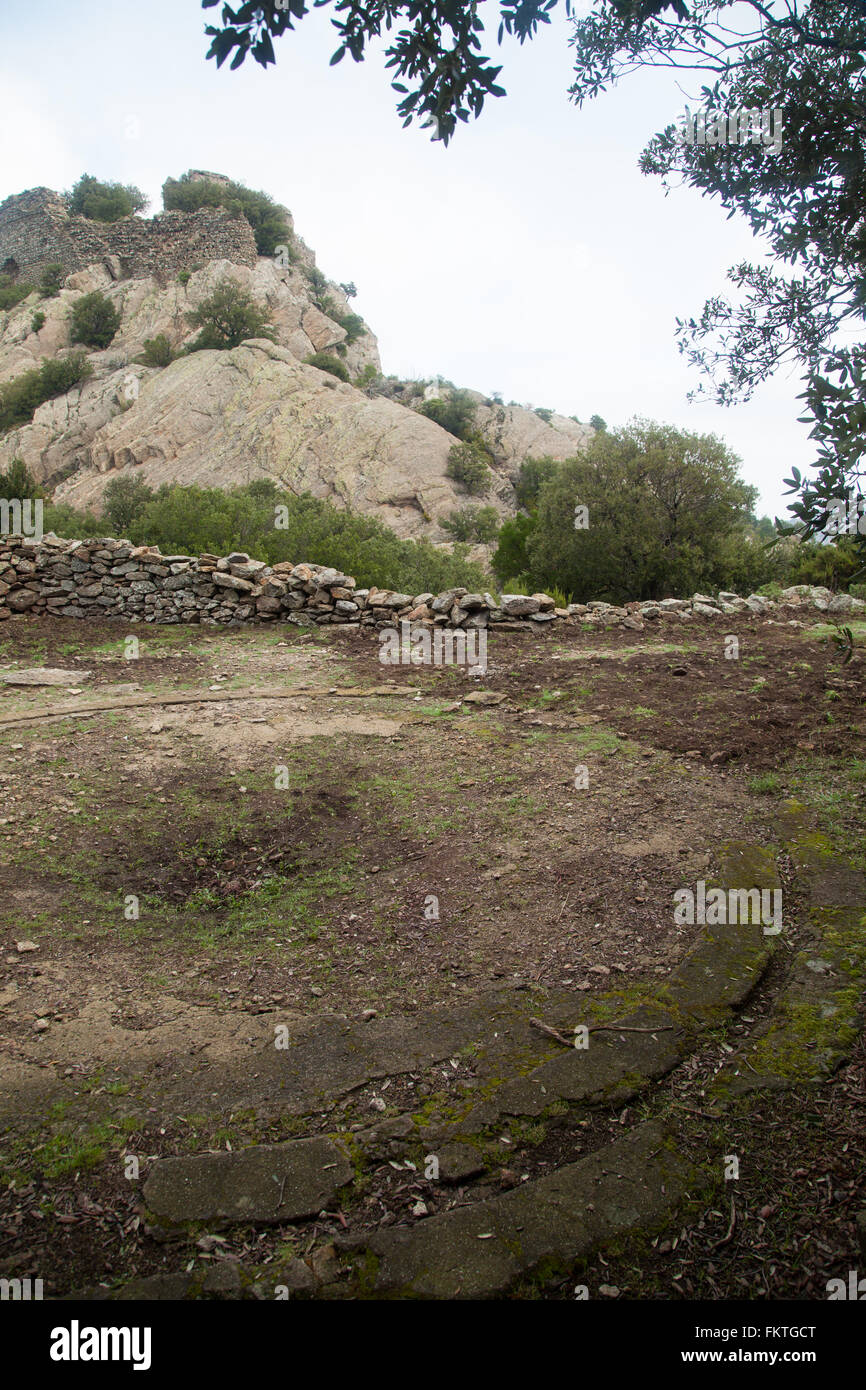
[145,1138,352,1225]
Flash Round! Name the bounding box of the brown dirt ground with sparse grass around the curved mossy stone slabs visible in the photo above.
[0,610,866,1297]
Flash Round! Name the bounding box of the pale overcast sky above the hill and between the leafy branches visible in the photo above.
[0,0,813,516]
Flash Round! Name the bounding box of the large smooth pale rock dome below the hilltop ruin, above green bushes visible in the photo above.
[52,339,480,535]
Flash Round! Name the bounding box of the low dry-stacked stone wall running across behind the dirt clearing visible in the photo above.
[0,534,866,631]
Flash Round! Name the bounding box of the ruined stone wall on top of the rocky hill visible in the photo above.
[0,188,257,279]
